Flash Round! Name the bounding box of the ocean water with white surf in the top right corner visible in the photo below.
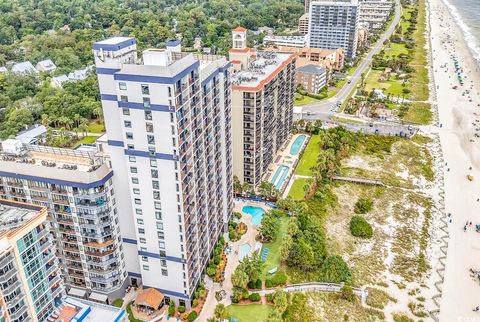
[443,0,480,62]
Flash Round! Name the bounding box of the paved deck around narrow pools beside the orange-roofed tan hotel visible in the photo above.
[263,133,310,193]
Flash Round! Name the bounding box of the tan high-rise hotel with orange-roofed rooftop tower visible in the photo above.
[229,27,296,186]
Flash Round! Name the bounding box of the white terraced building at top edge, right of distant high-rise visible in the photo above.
[359,0,393,29]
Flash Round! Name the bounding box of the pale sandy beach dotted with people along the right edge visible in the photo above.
[427,0,480,321]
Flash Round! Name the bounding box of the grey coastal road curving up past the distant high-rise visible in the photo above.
[303,0,401,115]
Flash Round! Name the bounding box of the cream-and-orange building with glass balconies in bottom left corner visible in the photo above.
[0,199,65,322]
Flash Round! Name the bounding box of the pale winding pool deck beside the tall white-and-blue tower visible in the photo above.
[196,199,271,321]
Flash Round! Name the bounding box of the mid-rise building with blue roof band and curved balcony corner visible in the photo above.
[0,139,127,302]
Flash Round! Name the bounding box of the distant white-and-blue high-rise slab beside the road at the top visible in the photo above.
[307,0,360,58]
